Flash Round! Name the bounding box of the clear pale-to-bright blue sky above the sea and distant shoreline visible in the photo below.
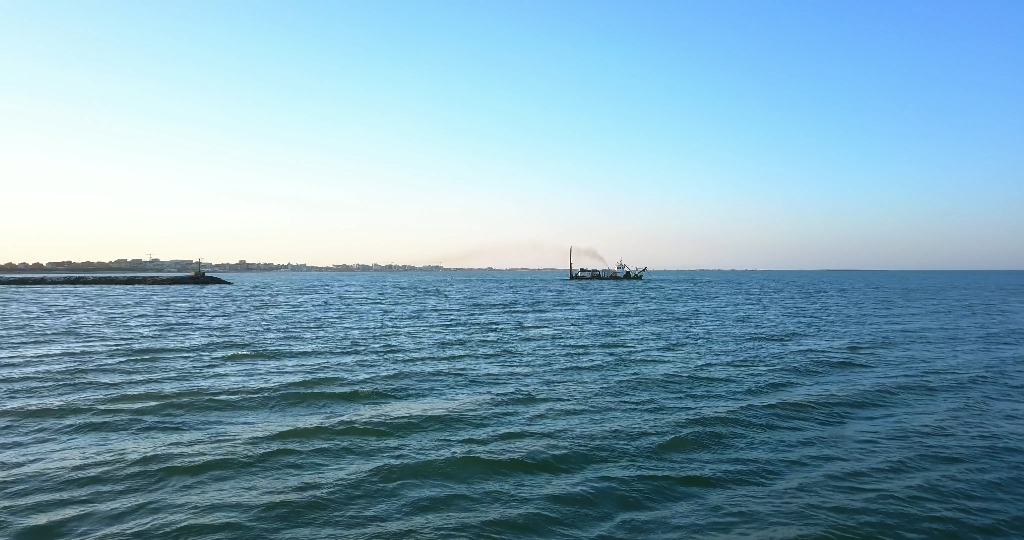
[0,0,1024,269]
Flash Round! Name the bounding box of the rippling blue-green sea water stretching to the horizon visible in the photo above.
[0,272,1024,539]
